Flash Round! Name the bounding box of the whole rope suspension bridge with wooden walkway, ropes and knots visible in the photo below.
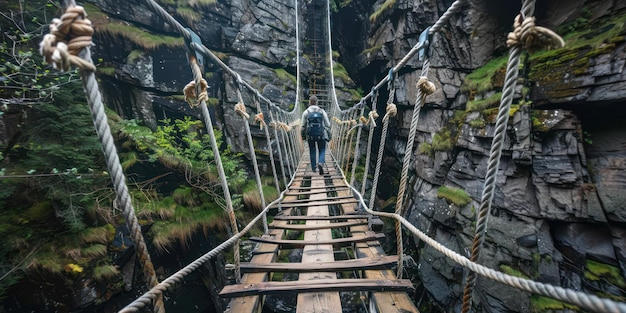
[41,0,626,312]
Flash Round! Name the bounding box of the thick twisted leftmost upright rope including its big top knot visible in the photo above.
[41,1,165,313]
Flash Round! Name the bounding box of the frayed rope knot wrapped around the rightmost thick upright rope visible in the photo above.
[506,14,565,51]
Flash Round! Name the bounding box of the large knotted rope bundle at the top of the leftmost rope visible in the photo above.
[39,6,96,72]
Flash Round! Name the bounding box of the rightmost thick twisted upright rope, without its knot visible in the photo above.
[461,0,535,313]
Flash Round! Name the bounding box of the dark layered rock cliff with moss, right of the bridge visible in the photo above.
[335,0,626,312]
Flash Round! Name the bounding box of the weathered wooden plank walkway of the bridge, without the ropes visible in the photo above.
[220,151,418,313]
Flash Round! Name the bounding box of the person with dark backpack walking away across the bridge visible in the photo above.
[300,95,332,175]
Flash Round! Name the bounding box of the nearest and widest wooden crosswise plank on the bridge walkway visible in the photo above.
[220,279,414,298]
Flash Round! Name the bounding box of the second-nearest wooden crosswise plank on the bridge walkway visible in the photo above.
[240,256,398,273]
